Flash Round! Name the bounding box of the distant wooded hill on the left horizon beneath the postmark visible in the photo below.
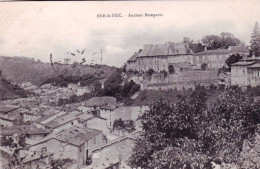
[0,56,116,85]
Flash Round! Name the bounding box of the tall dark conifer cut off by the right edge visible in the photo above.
[250,22,260,56]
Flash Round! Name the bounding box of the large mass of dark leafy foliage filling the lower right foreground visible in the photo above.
[129,87,260,169]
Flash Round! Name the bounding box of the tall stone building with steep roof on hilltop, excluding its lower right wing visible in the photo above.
[126,42,193,72]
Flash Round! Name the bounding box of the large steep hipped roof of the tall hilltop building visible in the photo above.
[137,43,193,57]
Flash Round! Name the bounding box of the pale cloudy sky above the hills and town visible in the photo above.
[0,0,260,66]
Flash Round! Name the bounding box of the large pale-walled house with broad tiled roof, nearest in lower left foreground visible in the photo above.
[29,126,107,167]
